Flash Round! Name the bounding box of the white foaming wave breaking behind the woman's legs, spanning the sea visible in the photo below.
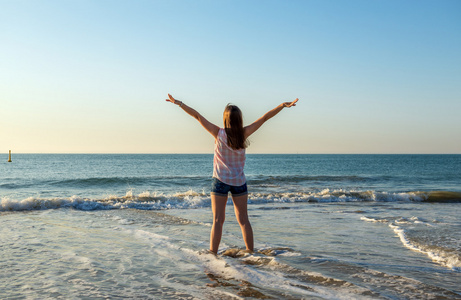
[0,189,461,211]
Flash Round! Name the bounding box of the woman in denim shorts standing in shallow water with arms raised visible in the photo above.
[166,94,298,254]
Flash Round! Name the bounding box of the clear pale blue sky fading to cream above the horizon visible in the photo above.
[0,0,461,153]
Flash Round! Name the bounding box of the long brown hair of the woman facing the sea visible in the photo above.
[223,104,248,150]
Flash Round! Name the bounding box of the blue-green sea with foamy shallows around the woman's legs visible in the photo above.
[0,153,461,299]
